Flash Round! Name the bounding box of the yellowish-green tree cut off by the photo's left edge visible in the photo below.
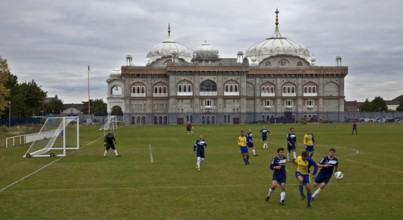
[0,56,10,116]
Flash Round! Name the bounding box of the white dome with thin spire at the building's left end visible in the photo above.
[147,26,192,63]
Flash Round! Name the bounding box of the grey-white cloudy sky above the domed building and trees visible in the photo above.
[0,0,403,103]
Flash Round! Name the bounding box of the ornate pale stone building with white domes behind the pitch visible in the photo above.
[107,10,348,124]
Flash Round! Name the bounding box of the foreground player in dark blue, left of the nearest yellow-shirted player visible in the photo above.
[266,148,287,205]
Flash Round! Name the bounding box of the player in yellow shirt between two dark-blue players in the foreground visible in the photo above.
[292,151,318,208]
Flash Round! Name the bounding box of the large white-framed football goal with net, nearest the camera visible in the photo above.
[23,117,79,157]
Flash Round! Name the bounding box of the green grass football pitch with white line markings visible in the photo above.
[0,123,403,220]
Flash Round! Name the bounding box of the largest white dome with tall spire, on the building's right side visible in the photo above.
[245,10,311,65]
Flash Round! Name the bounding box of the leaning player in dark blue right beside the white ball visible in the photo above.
[312,148,339,199]
